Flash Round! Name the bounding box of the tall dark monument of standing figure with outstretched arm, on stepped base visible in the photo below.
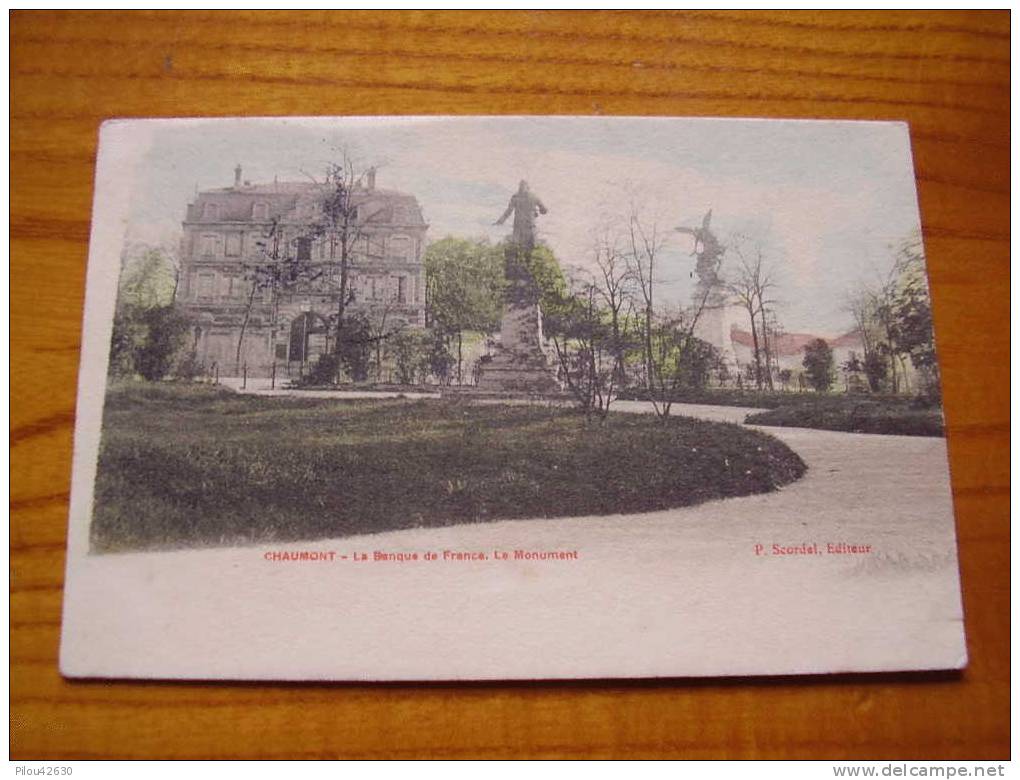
[477,181,561,394]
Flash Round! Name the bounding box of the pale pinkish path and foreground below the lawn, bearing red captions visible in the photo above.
[65,383,966,679]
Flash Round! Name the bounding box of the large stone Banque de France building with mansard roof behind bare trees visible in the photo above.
[176,165,428,376]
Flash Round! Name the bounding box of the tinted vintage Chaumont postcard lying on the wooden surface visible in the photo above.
[60,117,966,680]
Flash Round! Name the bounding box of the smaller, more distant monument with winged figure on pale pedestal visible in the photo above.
[676,209,742,370]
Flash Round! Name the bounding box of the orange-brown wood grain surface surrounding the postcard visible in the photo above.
[10,11,1010,759]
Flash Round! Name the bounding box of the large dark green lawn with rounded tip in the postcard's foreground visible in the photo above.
[91,383,806,553]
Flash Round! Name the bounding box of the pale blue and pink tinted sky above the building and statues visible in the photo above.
[115,117,920,335]
